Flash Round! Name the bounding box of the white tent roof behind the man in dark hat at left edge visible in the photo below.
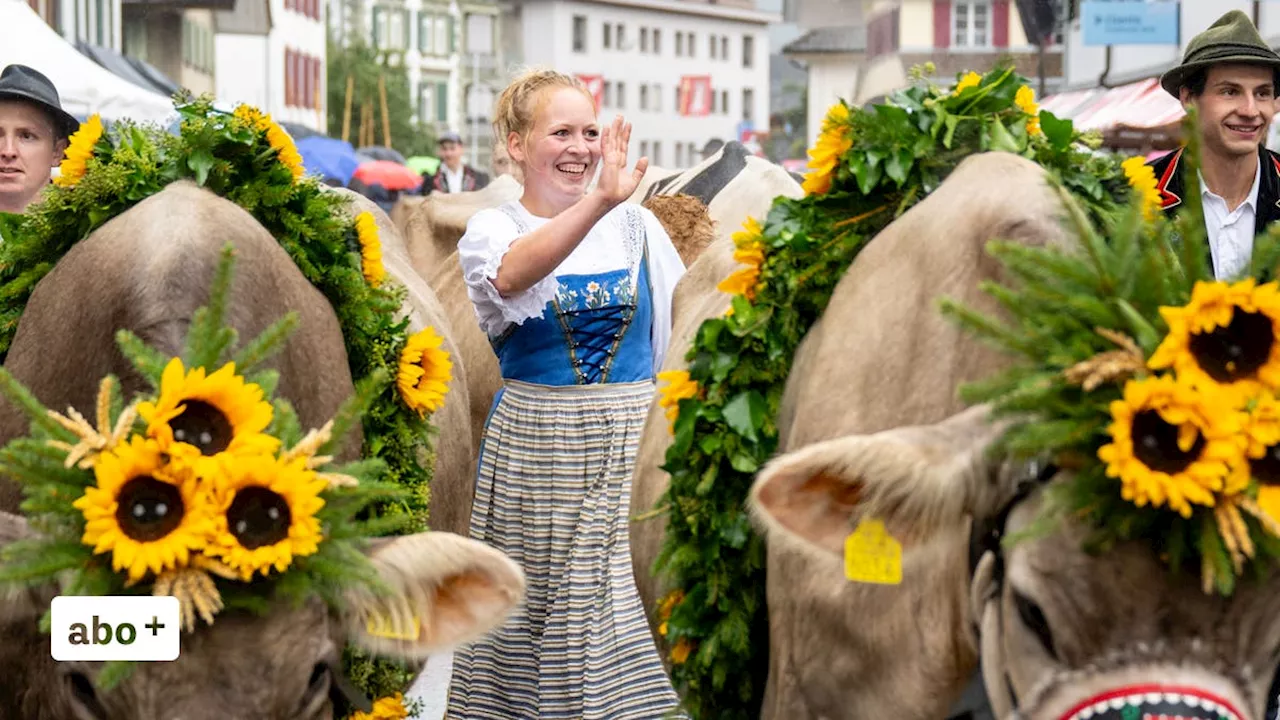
[0,0,175,124]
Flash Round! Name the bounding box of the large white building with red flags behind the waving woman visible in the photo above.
[517,0,782,168]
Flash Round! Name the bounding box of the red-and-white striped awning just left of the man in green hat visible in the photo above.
[1041,78,1187,133]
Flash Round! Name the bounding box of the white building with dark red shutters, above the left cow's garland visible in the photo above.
[214,0,326,133]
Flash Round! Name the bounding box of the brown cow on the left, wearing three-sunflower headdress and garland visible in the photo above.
[0,182,524,720]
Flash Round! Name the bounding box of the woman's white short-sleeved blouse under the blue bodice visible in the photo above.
[458,200,685,373]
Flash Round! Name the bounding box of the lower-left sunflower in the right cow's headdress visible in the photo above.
[1098,375,1244,518]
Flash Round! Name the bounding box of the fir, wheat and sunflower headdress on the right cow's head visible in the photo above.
[943,110,1280,594]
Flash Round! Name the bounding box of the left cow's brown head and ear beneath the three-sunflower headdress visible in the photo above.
[0,512,525,720]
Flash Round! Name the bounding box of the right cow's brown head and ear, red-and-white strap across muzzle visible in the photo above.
[751,406,1280,720]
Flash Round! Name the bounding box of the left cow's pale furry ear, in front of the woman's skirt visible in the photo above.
[346,532,525,660]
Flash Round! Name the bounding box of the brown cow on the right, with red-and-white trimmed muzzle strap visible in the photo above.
[753,154,1280,720]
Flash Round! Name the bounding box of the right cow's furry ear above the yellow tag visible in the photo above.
[751,405,1006,555]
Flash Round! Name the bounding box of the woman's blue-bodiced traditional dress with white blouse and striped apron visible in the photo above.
[447,201,685,720]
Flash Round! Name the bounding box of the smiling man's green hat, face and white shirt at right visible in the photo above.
[1151,10,1280,279]
